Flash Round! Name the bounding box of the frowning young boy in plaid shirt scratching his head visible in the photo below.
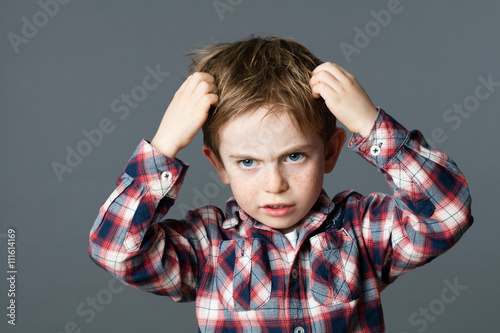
[90,36,472,333]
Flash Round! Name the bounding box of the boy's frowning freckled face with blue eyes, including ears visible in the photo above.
[203,107,345,233]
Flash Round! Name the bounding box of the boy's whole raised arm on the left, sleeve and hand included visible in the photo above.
[89,73,218,301]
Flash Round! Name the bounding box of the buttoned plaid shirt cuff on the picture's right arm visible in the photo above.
[348,107,410,169]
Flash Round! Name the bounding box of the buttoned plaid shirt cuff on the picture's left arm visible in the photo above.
[124,139,189,199]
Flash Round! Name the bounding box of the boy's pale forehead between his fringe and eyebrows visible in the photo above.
[219,107,320,153]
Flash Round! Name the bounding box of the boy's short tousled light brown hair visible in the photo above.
[188,35,336,159]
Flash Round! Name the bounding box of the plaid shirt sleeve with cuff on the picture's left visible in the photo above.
[89,140,212,301]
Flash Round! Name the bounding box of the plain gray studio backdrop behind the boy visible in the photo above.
[0,0,500,333]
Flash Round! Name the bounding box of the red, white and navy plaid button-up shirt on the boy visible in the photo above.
[90,109,472,333]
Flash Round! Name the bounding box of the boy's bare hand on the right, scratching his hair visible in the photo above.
[310,62,378,136]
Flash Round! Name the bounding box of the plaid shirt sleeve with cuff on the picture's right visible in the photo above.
[348,108,473,283]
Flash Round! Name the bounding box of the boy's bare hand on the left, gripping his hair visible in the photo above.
[151,72,219,158]
